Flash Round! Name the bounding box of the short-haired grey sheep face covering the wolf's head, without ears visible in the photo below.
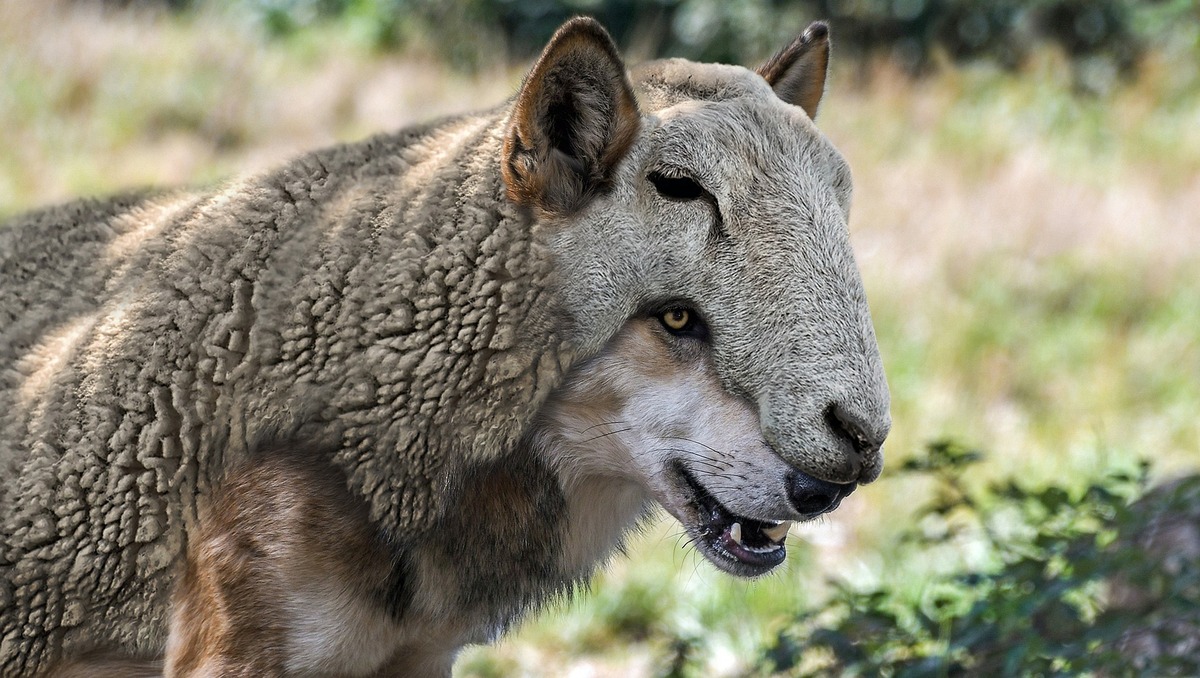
[564,60,890,482]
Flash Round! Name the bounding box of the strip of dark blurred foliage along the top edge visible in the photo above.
[189,0,1198,78]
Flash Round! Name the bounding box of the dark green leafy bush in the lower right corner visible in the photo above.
[760,442,1200,677]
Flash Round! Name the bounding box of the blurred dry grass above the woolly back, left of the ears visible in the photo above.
[0,2,520,215]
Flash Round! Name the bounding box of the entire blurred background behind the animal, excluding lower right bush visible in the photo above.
[0,0,1200,677]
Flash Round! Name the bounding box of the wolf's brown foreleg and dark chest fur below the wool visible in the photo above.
[157,445,565,677]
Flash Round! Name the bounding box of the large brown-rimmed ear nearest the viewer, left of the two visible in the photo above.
[502,18,641,215]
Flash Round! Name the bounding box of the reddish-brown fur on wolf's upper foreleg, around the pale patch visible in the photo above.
[167,450,389,677]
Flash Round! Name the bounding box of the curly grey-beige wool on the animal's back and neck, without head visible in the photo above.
[0,110,574,676]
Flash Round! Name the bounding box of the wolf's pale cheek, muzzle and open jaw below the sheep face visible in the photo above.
[538,317,854,577]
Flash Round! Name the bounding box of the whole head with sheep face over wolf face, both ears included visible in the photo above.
[502,19,890,575]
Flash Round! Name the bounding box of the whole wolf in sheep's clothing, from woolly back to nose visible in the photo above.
[0,19,889,677]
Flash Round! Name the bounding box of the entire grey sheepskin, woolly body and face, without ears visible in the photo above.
[0,15,889,676]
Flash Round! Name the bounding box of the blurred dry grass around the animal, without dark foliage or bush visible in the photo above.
[0,2,1200,676]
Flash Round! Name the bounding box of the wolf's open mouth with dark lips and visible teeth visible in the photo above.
[673,460,792,577]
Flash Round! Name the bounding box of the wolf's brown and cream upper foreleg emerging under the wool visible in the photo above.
[166,449,397,677]
